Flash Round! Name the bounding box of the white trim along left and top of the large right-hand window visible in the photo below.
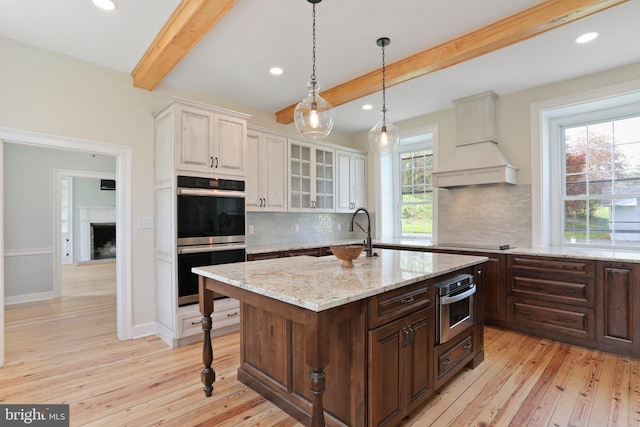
[530,80,640,248]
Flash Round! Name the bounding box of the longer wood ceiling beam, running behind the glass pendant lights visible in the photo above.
[276,0,628,124]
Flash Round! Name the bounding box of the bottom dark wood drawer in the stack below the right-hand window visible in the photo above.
[507,297,594,339]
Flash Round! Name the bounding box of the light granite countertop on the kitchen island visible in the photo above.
[192,249,487,312]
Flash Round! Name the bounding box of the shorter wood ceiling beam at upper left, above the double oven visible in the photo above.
[131,0,236,90]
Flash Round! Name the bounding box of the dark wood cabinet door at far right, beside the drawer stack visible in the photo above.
[596,262,640,351]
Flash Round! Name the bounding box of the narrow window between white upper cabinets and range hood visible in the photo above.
[397,145,433,239]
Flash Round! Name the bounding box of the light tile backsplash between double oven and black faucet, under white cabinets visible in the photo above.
[247,212,374,246]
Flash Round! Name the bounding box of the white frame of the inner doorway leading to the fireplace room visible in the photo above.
[53,169,120,298]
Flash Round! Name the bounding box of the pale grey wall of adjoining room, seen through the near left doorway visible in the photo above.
[3,143,115,302]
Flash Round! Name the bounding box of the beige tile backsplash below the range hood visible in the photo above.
[438,184,532,247]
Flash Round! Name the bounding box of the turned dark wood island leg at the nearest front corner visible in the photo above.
[305,311,329,427]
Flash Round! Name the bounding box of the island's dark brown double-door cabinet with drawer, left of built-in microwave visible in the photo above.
[368,280,435,426]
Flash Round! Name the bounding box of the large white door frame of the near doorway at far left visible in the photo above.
[0,128,133,367]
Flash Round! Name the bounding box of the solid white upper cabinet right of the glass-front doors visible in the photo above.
[336,150,367,212]
